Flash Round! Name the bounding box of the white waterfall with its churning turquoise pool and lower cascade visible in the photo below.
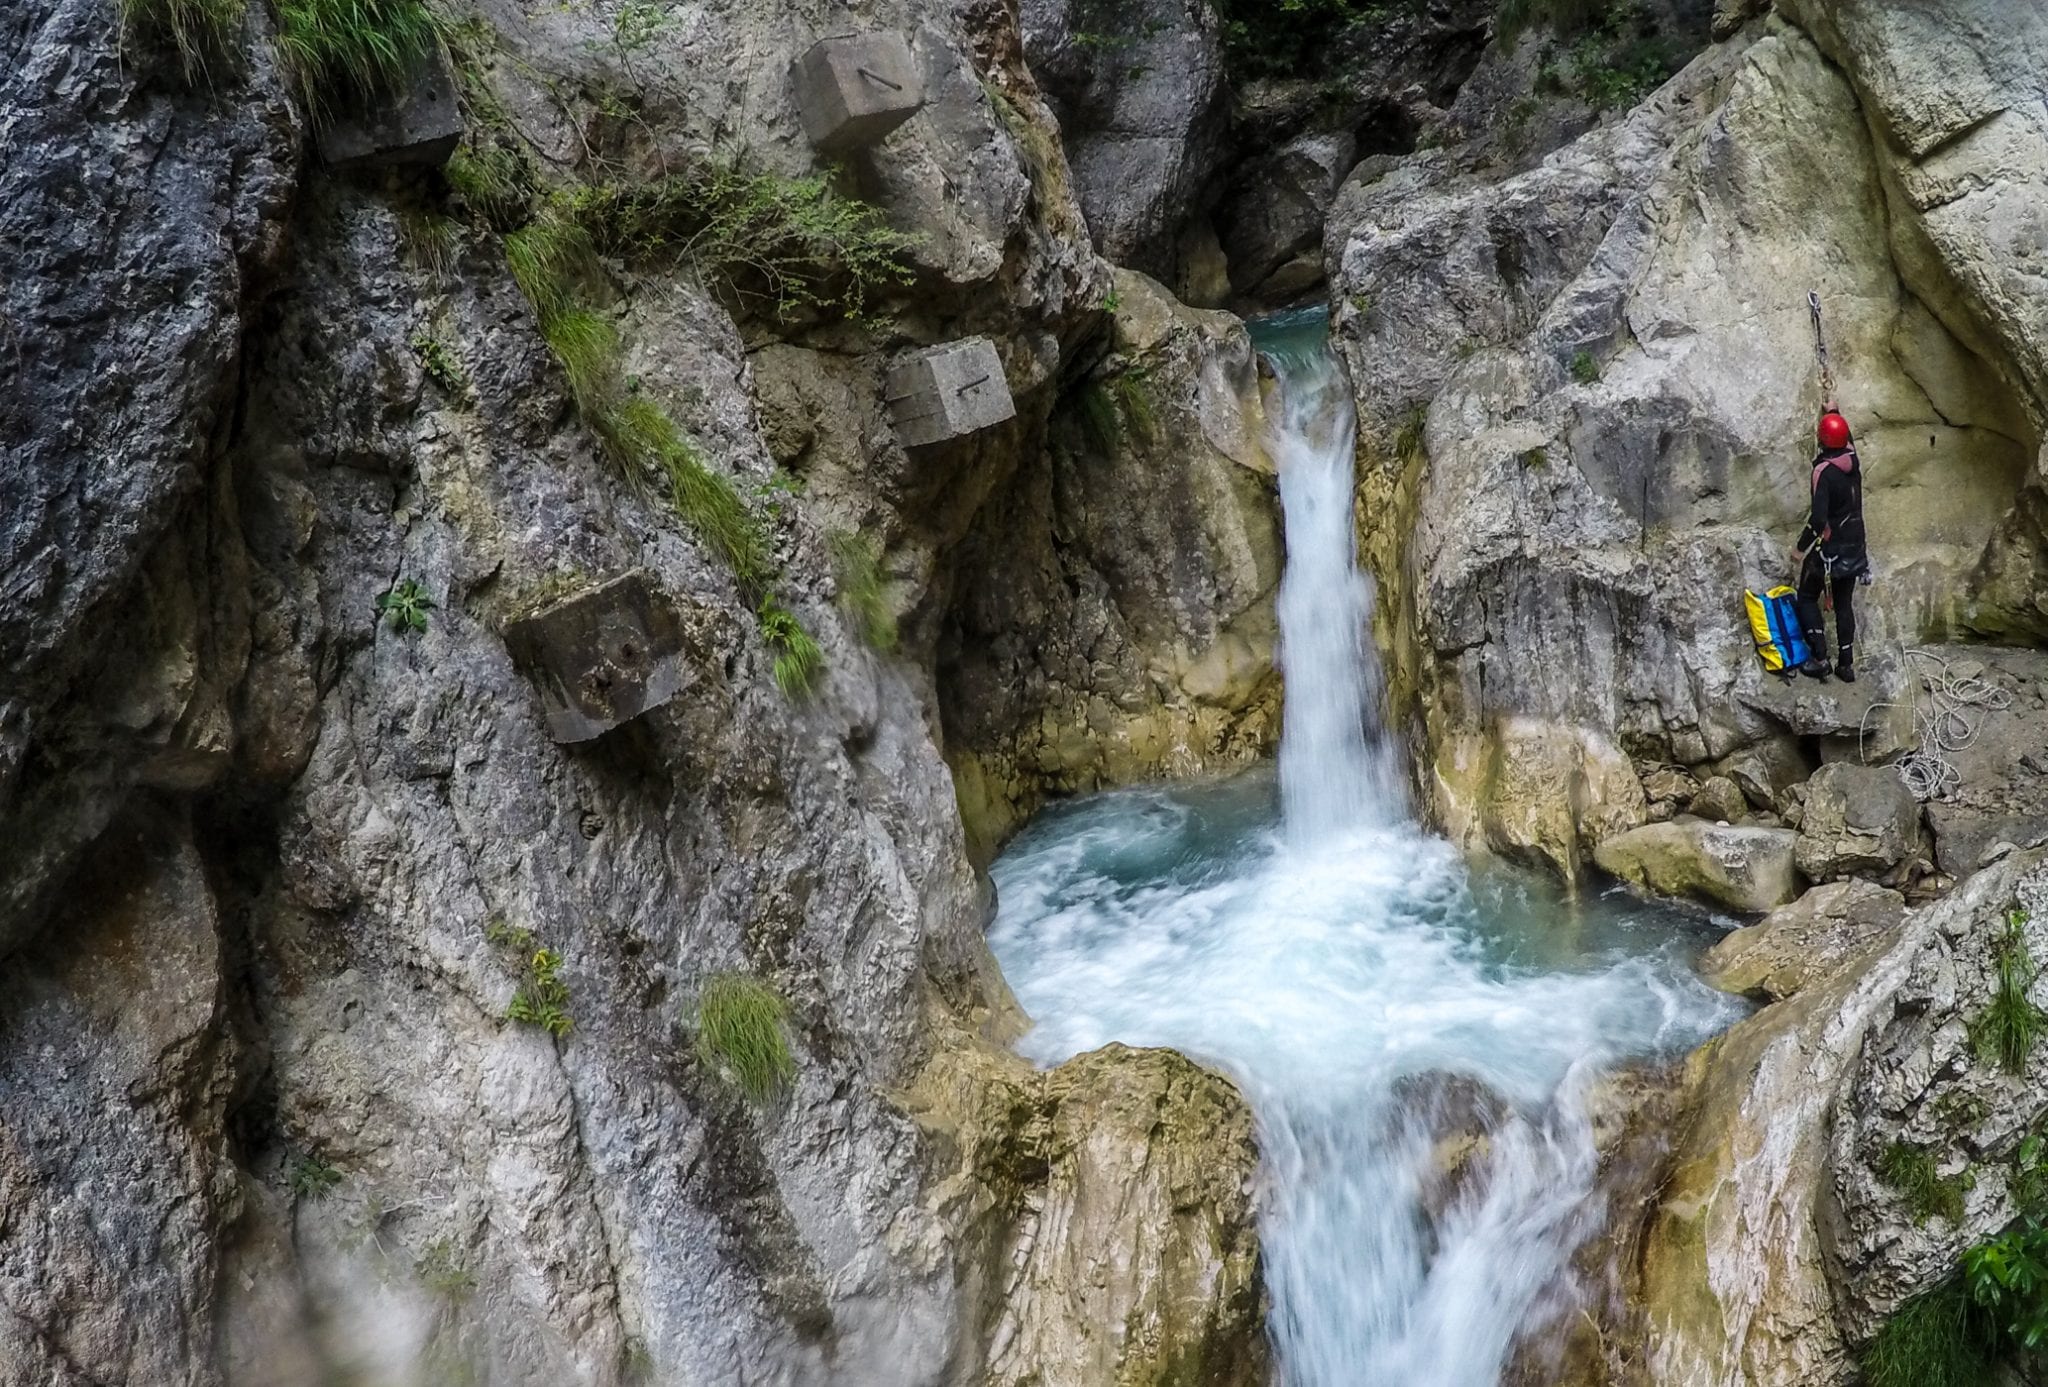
[989,320,1741,1387]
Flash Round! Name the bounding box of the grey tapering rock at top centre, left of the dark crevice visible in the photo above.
[1020,0,1229,285]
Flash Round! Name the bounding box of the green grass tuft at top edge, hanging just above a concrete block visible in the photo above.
[274,0,440,121]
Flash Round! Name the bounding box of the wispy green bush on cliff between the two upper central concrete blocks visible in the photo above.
[575,160,920,318]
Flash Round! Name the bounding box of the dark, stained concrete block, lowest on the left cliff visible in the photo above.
[506,570,690,742]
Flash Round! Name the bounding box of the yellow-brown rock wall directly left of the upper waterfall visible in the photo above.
[940,270,1282,854]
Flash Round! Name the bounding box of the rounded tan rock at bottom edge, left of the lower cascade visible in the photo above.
[913,1045,1266,1387]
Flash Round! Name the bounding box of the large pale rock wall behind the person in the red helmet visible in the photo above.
[1325,0,2048,876]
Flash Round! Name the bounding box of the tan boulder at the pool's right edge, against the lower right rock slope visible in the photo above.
[1700,879,1907,1002]
